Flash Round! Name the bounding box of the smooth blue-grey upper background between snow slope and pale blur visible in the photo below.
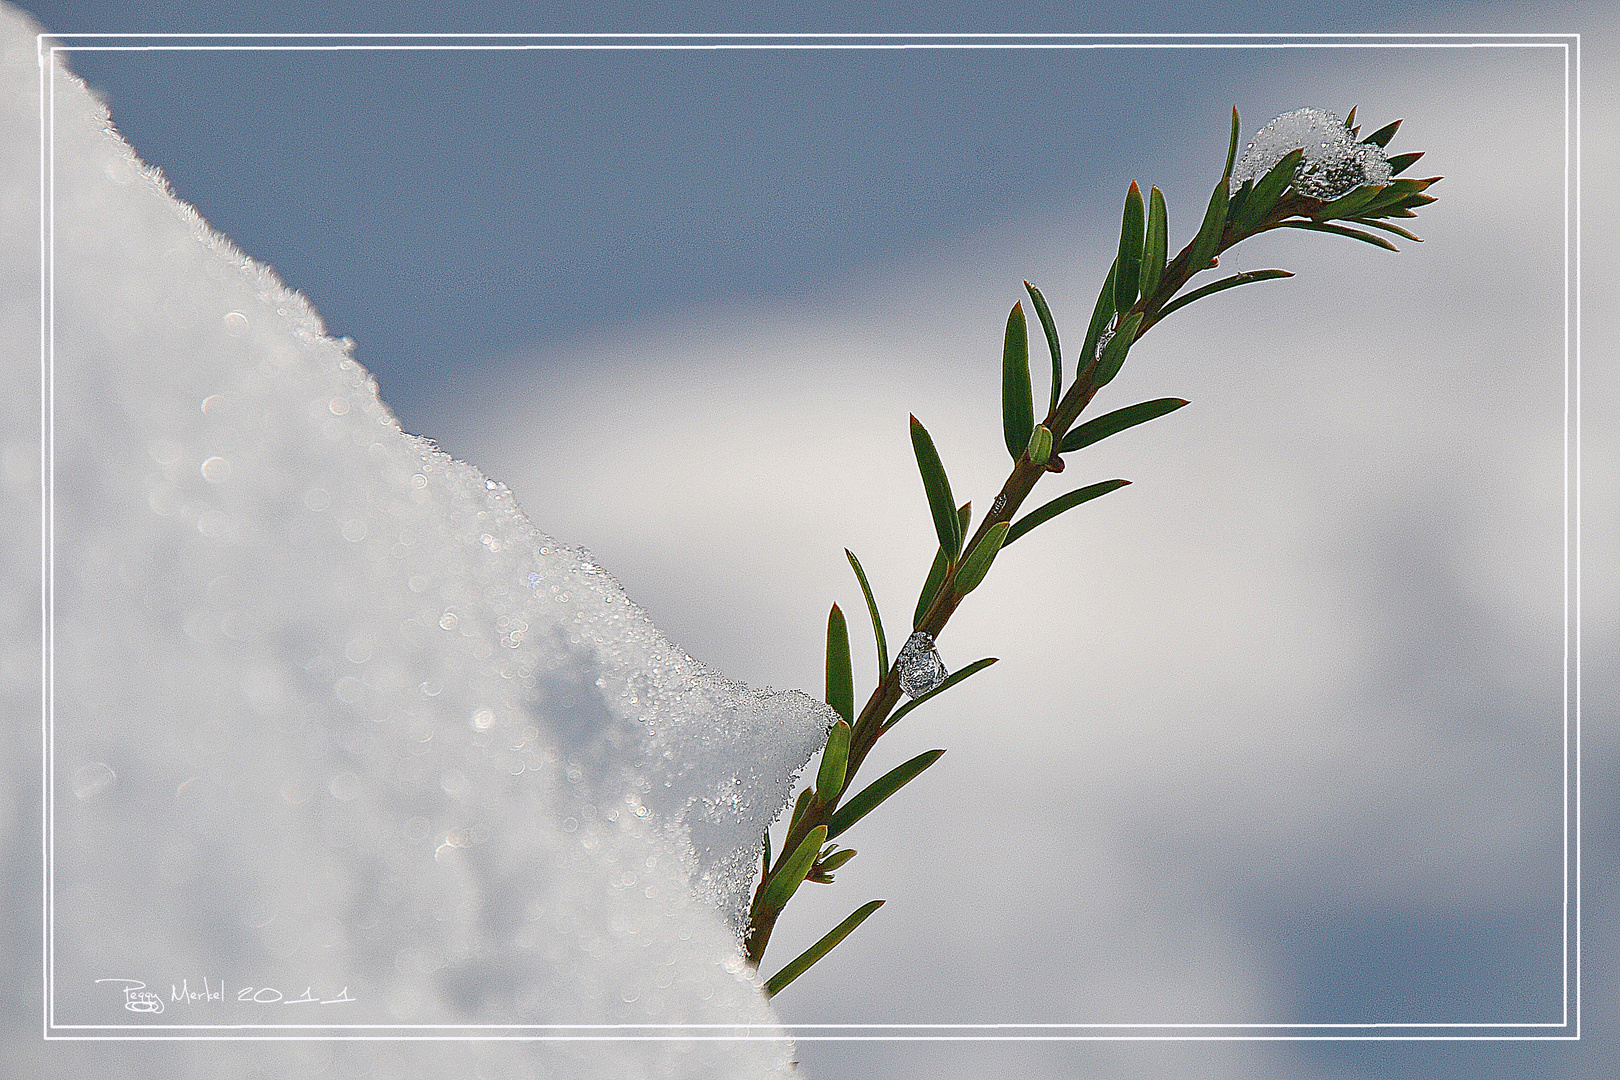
[9,3,1594,427]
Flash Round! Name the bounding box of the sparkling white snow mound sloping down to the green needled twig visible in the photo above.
[0,8,831,1080]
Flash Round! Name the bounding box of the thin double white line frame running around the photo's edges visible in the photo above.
[37,32,1581,1041]
